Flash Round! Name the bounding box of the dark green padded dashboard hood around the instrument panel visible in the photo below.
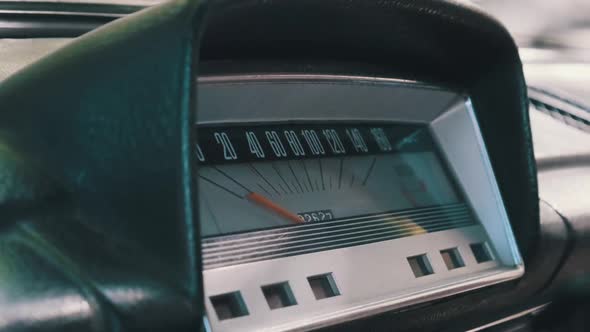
[0,0,539,331]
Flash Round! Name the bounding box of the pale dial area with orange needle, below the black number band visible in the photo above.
[200,152,459,236]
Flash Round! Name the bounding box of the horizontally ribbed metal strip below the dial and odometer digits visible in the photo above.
[203,206,475,269]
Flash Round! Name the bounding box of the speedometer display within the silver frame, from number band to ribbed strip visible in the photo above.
[196,124,475,267]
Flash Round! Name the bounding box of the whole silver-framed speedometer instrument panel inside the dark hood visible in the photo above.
[195,75,523,331]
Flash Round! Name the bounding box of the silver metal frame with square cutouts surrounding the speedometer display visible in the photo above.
[197,74,524,331]
